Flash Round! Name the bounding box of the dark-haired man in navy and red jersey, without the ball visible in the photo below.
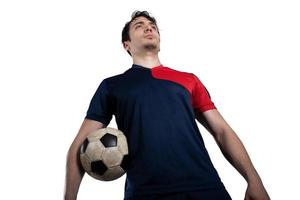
[65,11,270,200]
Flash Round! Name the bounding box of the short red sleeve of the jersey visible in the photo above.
[192,74,216,112]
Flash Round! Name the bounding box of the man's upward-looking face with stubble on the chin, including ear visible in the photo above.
[124,17,160,55]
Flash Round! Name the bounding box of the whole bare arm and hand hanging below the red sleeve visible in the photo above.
[196,109,270,200]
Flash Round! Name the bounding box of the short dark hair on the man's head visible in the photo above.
[122,10,159,56]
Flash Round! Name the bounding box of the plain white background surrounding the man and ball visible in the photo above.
[0,0,300,200]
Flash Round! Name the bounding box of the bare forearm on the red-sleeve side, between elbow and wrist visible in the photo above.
[216,127,261,183]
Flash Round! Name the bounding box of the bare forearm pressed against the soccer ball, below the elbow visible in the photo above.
[65,144,84,200]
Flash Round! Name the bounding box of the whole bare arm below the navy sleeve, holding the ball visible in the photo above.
[64,119,105,200]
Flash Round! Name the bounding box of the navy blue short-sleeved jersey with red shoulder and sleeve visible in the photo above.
[86,64,224,198]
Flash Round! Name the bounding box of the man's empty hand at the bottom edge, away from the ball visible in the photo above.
[245,182,270,200]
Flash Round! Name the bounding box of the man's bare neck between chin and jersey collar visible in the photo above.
[132,52,161,68]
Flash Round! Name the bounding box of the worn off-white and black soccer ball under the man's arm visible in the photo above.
[80,127,128,181]
